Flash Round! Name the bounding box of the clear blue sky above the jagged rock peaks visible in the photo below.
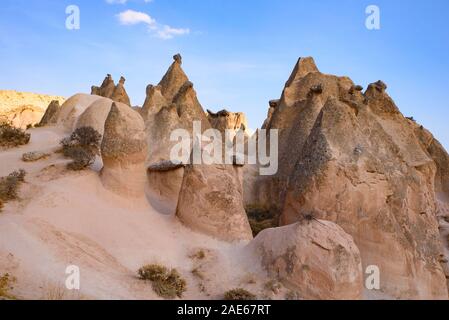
[0,0,449,148]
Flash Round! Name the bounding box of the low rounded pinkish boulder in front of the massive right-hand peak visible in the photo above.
[247,219,363,300]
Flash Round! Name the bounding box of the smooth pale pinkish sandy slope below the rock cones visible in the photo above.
[0,128,267,299]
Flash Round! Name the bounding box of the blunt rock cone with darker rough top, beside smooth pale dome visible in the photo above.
[101,103,148,197]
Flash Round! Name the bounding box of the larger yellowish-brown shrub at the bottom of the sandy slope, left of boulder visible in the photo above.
[138,264,187,299]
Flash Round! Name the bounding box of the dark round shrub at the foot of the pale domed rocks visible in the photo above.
[61,127,101,171]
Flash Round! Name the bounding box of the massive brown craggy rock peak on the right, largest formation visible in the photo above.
[246,58,449,299]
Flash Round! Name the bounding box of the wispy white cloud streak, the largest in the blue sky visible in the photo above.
[115,9,190,40]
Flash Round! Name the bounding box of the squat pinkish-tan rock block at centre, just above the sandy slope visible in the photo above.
[176,165,252,241]
